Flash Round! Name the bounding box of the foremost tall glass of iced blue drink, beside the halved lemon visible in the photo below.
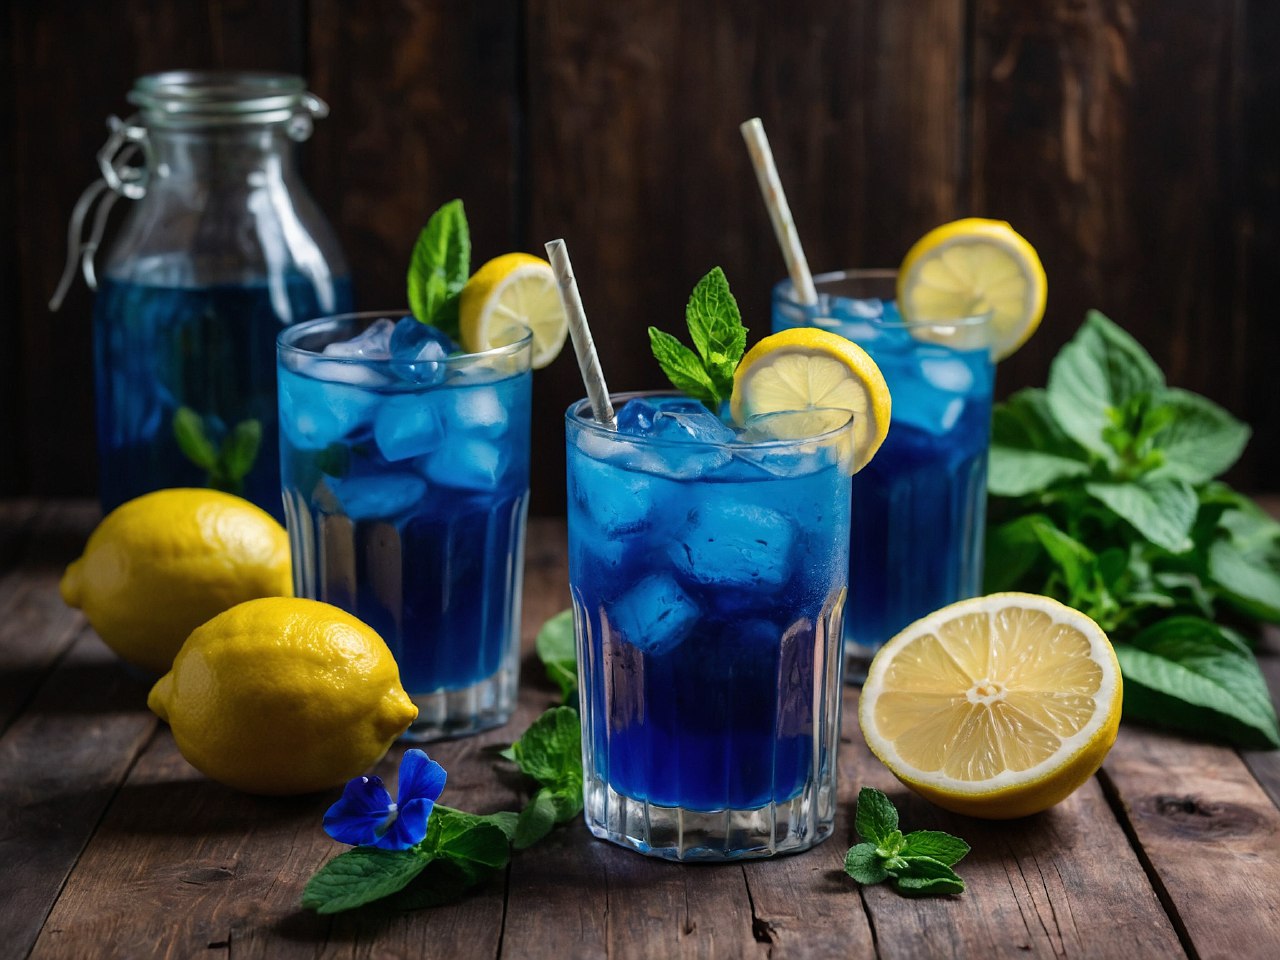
[566,394,850,860]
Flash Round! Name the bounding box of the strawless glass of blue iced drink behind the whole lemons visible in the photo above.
[278,314,531,740]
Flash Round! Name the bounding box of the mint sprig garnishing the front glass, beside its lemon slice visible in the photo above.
[649,266,746,413]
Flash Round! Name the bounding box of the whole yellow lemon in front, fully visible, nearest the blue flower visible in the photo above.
[147,596,417,794]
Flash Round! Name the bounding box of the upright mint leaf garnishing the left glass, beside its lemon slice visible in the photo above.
[408,200,471,340]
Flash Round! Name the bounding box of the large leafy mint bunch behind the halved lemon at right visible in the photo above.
[986,311,1280,746]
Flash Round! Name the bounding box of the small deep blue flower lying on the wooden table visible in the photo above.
[324,750,445,850]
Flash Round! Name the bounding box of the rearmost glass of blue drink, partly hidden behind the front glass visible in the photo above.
[772,270,995,681]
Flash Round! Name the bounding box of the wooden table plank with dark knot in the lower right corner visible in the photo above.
[1103,727,1280,960]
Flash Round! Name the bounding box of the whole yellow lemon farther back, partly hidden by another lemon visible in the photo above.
[61,488,293,673]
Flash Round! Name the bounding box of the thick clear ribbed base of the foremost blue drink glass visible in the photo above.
[584,777,836,861]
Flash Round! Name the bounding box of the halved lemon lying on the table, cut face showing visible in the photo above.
[859,593,1121,819]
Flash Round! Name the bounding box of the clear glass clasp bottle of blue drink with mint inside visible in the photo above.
[55,70,351,517]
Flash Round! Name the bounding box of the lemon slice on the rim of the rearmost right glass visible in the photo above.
[897,218,1048,360]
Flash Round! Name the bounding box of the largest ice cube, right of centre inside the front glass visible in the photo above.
[668,499,796,593]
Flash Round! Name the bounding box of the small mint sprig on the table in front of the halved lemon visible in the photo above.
[845,787,969,896]
